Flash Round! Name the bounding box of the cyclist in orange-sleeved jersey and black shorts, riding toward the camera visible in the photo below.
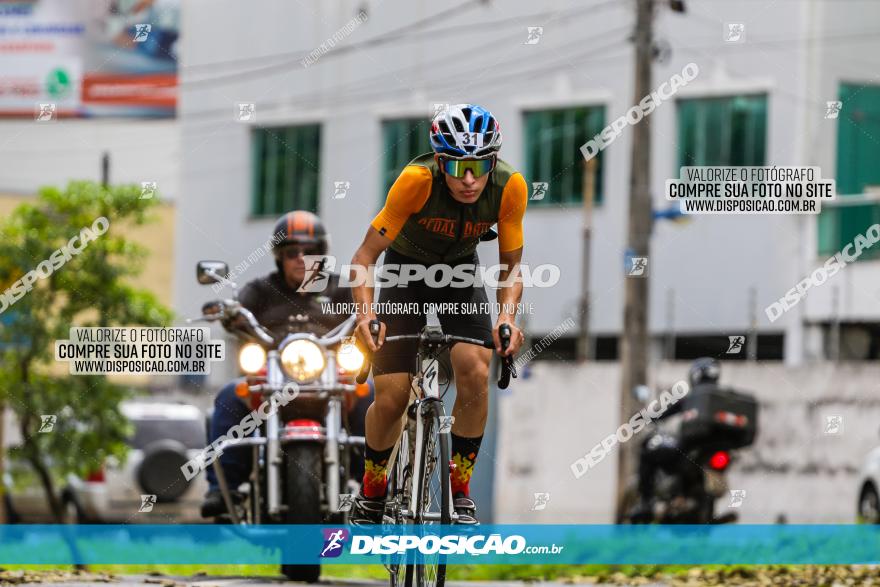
[351,104,528,524]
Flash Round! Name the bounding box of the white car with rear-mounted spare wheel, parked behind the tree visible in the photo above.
[4,401,207,524]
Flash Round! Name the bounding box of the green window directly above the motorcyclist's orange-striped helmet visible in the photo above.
[251,124,321,216]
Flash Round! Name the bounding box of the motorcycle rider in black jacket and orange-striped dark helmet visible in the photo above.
[201,210,358,518]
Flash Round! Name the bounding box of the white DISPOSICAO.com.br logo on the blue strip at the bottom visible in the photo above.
[321,531,564,557]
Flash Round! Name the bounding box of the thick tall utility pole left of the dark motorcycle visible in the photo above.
[617,0,654,519]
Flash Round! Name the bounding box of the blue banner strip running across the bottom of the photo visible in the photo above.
[0,524,880,565]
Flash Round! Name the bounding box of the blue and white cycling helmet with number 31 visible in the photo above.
[431,104,501,159]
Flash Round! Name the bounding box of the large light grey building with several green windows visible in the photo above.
[175,0,880,364]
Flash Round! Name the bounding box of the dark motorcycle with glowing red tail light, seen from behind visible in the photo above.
[618,386,758,524]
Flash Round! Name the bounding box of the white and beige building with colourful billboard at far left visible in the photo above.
[0,0,180,314]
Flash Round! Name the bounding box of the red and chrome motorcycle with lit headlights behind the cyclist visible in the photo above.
[194,261,369,582]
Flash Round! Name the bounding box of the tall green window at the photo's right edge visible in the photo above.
[818,84,880,261]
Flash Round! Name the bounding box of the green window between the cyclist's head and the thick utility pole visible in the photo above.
[524,106,605,207]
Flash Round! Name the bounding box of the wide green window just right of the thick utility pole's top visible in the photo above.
[676,95,767,168]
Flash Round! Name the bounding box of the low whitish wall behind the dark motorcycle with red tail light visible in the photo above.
[496,362,880,524]
